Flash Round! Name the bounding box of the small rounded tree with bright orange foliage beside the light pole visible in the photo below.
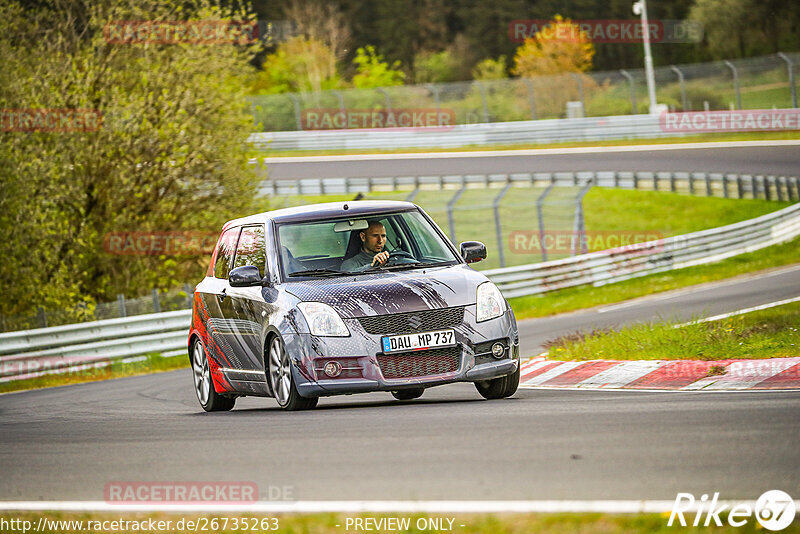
[512,15,594,77]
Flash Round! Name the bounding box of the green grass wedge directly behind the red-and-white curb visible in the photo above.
[548,303,800,361]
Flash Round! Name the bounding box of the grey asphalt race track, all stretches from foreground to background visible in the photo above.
[0,146,800,501]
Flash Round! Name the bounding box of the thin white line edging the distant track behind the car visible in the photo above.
[264,139,800,164]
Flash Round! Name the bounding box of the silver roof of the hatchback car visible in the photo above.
[223,200,418,229]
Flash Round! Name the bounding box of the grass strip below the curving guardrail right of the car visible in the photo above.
[509,237,800,320]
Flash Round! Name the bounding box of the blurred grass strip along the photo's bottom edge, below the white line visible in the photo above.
[0,512,800,534]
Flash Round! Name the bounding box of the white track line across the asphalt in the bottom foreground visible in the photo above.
[0,500,780,514]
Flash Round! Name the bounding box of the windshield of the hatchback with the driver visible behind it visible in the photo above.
[278,211,459,277]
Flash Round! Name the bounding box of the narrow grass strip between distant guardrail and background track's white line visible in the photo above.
[255,131,800,158]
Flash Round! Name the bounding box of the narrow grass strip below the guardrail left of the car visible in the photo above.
[0,354,189,393]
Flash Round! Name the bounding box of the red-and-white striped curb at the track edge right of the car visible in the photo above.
[520,356,800,391]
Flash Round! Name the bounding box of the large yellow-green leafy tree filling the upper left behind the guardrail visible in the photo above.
[0,0,258,322]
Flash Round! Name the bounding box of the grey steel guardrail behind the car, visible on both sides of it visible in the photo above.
[0,195,800,382]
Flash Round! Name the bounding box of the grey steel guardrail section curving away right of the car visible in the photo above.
[483,204,800,298]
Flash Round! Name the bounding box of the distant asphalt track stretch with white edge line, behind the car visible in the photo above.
[267,142,800,180]
